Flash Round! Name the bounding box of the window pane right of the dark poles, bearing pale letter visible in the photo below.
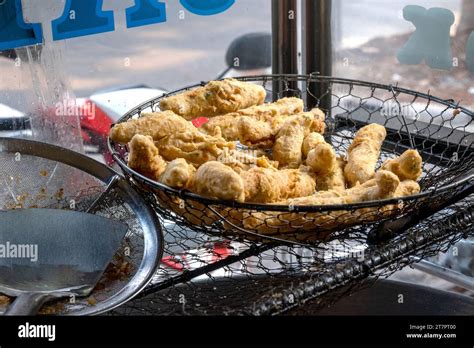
[333,0,474,106]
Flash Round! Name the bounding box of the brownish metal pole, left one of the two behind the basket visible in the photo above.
[272,0,298,99]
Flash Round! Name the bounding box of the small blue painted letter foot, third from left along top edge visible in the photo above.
[126,0,166,28]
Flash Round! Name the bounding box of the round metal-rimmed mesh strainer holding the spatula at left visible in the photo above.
[0,138,163,315]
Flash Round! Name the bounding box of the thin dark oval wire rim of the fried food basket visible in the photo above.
[107,74,474,212]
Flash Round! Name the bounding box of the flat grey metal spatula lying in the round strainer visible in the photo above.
[0,209,128,315]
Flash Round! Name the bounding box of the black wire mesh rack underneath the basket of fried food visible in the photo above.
[111,196,474,316]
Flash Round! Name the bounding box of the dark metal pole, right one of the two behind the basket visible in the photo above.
[303,0,333,112]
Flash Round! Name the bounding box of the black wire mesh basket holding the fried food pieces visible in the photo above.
[109,75,474,246]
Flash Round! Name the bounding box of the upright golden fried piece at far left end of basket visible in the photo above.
[128,134,167,181]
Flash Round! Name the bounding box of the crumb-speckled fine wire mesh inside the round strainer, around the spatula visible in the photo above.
[0,143,159,315]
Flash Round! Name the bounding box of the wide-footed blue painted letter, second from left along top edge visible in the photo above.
[52,0,115,40]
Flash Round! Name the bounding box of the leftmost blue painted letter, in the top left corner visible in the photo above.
[0,0,43,50]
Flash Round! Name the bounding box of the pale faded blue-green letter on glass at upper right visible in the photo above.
[398,5,454,70]
